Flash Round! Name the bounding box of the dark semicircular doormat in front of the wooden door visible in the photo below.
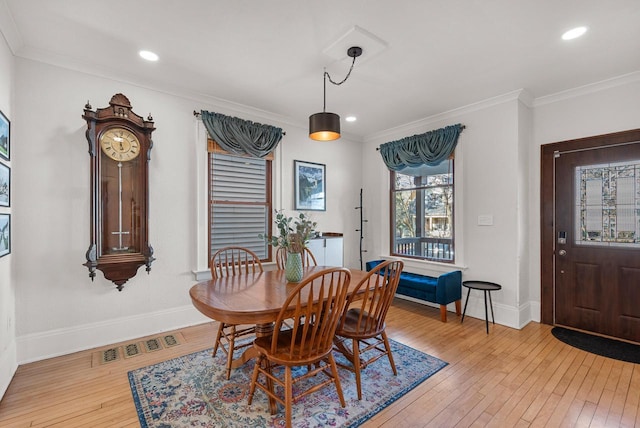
[551,327,640,364]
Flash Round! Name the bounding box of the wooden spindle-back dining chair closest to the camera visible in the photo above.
[249,267,351,427]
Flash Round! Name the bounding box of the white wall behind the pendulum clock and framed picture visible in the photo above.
[12,59,361,363]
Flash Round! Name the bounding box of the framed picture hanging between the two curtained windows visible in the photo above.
[293,161,327,211]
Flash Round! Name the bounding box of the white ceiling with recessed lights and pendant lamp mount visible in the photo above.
[0,0,640,139]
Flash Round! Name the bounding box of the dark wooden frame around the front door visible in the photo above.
[540,129,640,325]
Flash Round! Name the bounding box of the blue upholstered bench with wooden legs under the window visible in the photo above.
[366,260,462,322]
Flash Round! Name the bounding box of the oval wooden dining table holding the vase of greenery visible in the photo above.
[189,266,368,368]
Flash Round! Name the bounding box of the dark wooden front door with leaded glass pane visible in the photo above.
[553,141,640,342]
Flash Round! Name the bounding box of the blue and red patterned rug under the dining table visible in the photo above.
[129,340,447,428]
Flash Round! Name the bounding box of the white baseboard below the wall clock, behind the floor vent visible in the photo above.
[17,305,211,364]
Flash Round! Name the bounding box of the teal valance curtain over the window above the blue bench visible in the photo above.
[380,124,464,171]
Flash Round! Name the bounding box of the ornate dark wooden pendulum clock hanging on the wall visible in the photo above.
[82,94,155,291]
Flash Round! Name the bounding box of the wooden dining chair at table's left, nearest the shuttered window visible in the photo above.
[209,247,263,379]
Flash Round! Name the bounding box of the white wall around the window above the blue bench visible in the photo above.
[363,92,526,327]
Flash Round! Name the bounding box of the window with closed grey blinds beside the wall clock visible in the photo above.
[209,141,272,260]
